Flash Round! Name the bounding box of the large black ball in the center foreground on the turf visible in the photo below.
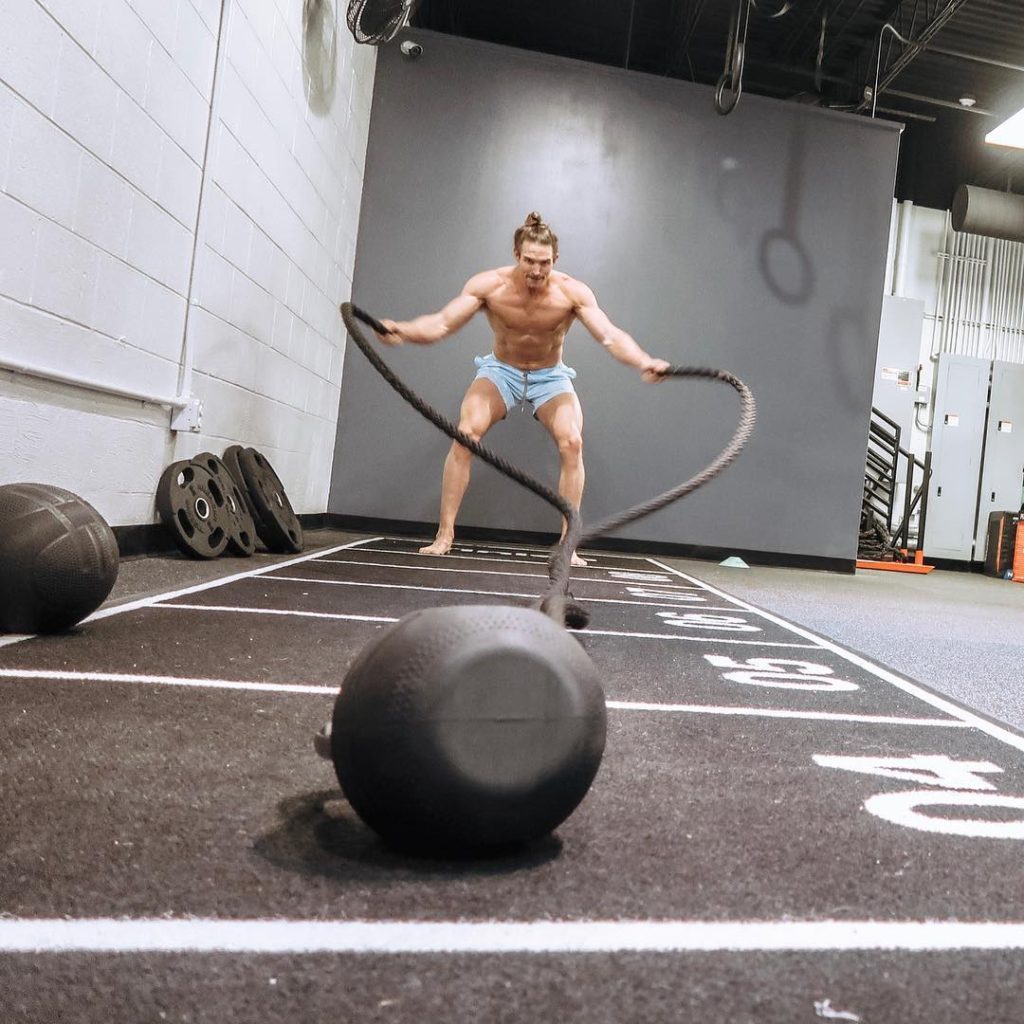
[331,605,606,852]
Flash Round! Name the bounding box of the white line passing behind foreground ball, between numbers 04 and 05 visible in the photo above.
[0,669,969,729]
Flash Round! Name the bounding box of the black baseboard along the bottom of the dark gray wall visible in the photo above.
[325,512,856,574]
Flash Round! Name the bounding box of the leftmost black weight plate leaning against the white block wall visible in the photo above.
[157,460,227,558]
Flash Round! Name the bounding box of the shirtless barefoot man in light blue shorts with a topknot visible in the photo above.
[378,213,669,565]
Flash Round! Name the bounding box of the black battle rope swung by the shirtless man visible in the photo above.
[341,302,757,628]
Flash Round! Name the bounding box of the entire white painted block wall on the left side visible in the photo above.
[0,0,375,525]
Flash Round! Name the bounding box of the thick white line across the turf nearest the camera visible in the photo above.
[6,918,1024,954]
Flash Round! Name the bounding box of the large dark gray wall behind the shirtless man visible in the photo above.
[328,32,899,563]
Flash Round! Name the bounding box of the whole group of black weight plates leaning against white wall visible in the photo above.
[157,444,302,558]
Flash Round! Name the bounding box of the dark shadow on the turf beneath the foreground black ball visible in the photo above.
[254,790,562,880]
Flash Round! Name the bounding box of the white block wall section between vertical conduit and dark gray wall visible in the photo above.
[189,0,374,511]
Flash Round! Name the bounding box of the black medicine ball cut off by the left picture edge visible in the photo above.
[0,483,119,633]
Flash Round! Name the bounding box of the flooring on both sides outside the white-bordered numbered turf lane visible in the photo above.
[110,529,1024,729]
